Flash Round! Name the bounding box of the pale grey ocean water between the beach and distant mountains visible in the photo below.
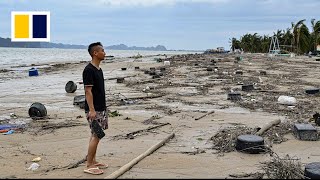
[0,47,202,69]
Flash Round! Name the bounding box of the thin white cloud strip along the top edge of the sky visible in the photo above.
[99,0,230,7]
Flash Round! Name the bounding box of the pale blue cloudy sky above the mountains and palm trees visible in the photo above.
[0,0,320,50]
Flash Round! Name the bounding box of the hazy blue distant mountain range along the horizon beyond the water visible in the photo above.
[0,37,167,51]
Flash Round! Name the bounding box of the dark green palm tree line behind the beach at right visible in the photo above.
[230,19,320,54]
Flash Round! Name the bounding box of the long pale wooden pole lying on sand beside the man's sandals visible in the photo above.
[105,133,174,179]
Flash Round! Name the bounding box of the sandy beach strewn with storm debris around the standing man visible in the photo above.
[0,54,320,179]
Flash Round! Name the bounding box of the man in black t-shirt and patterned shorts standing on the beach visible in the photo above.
[82,42,108,175]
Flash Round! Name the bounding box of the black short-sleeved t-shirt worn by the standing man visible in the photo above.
[82,63,106,112]
